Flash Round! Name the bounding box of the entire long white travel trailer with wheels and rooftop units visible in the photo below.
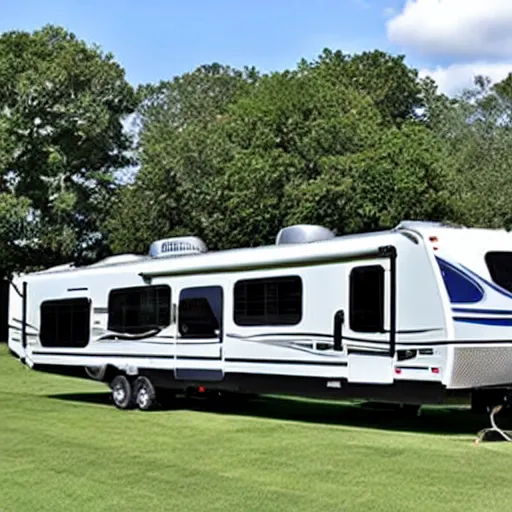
[9,222,512,409]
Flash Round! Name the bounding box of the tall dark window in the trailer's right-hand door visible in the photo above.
[350,265,384,332]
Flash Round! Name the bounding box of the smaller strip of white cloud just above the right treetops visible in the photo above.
[420,61,512,96]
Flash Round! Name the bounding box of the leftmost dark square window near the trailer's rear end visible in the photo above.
[39,298,91,348]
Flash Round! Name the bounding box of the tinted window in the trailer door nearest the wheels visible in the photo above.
[178,286,222,338]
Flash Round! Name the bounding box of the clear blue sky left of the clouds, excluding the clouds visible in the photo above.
[0,0,412,84]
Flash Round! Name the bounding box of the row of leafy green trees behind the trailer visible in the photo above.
[0,26,512,275]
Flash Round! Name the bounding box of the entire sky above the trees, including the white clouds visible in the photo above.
[0,0,512,92]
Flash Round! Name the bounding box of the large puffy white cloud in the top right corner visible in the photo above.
[387,0,512,60]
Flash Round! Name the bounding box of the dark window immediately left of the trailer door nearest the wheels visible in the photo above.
[108,285,171,334]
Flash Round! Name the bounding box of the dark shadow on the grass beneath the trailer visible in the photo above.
[49,392,504,435]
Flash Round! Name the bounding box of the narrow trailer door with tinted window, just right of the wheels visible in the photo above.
[175,286,223,381]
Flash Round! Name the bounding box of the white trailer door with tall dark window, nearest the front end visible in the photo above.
[342,258,396,384]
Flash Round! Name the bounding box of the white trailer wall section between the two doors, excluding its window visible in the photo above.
[220,264,347,378]
